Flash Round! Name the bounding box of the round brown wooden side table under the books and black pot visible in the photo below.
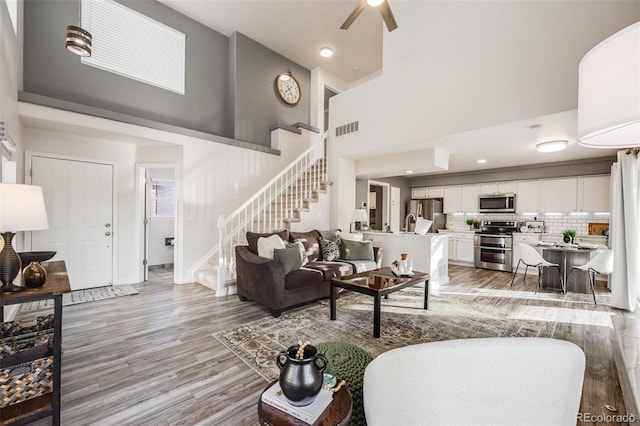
[258,379,352,426]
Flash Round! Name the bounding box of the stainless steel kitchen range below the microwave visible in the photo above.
[474,221,518,272]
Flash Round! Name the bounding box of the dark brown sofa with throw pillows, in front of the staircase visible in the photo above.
[235,230,382,317]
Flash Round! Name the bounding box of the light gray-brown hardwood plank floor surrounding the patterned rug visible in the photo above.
[27,266,625,425]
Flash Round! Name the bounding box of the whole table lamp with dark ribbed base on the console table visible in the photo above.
[0,183,49,293]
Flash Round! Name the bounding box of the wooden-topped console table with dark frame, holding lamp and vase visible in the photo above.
[0,261,71,426]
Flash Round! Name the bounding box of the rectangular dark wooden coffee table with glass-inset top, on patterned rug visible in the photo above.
[331,268,430,337]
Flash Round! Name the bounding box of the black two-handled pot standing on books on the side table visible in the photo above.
[276,345,327,407]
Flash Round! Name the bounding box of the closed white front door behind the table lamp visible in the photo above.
[31,156,113,290]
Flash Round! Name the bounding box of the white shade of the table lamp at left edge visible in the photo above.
[0,183,49,232]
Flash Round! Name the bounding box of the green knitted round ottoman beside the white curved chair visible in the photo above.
[316,342,372,426]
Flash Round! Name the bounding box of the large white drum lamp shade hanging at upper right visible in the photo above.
[578,22,640,148]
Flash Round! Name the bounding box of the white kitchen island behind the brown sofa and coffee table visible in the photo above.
[363,232,449,289]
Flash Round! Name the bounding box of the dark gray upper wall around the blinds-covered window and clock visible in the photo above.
[23,0,310,148]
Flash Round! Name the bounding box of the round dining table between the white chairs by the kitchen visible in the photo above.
[535,244,606,294]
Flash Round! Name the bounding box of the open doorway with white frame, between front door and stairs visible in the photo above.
[139,164,177,282]
